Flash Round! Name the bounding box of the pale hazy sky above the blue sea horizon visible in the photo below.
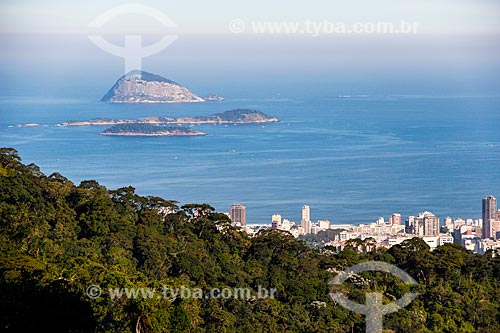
[0,0,500,95]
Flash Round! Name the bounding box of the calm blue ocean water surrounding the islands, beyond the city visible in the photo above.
[0,95,500,223]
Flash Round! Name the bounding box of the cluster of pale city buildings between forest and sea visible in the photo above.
[234,195,500,254]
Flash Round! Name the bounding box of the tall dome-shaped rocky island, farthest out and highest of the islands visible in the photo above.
[101,71,205,103]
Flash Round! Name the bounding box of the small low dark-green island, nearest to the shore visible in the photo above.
[100,123,206,136]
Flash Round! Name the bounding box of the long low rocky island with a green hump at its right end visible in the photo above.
[60,109,278,126]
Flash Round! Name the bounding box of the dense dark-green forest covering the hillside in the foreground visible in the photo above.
[0,148,500,333]
